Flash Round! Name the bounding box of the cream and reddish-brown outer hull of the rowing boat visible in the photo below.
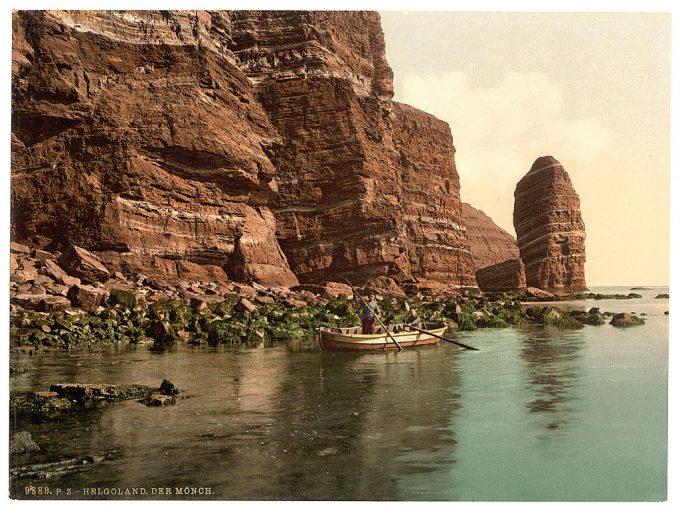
[319,325,446,351]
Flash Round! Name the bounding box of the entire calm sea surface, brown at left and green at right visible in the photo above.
[10,287,668,501]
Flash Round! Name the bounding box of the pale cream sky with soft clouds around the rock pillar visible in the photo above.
[381,12,671,286]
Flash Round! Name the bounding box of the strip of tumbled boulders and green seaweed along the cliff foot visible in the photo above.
[10,243,644,356]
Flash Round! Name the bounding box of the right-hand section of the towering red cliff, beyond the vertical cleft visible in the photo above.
[232,12,476,287]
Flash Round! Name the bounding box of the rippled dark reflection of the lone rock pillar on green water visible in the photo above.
[521,327,585,430]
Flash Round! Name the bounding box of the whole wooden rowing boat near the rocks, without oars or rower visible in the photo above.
[319,323,446,351]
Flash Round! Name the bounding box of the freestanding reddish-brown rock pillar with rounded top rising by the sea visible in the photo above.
[513,156,586,292]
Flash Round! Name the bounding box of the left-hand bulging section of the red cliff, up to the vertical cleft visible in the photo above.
[12,11,297,285]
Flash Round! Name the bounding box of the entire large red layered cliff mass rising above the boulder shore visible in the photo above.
[12,11,475,287]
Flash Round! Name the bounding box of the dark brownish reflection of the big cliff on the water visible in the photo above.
[11,344,468,500]
